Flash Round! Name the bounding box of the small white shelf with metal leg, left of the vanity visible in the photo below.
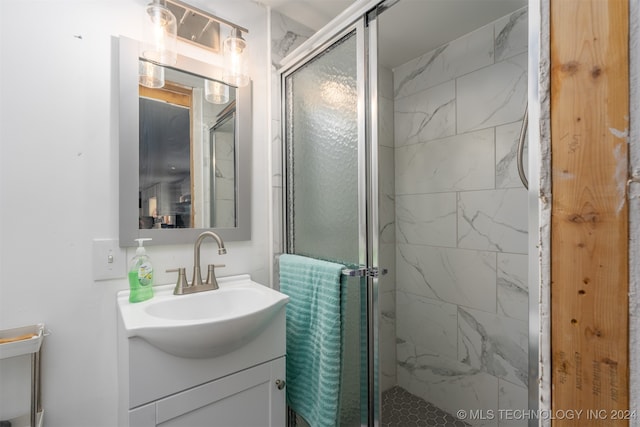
[0,323,45,427]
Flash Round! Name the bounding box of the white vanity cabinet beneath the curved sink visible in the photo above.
[118,298,286,427]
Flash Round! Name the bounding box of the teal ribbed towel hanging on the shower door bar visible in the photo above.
[280,254,344,427]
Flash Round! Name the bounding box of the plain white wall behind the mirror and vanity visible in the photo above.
[0,0,270,426]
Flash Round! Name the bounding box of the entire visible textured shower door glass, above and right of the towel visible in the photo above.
[283,28,367,426]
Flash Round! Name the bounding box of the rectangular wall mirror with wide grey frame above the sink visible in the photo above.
[119,37,252,247]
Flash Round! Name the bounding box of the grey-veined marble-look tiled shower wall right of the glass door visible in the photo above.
[393,9,528,426]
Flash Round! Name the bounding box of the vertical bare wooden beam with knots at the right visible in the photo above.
[550,0,631,427]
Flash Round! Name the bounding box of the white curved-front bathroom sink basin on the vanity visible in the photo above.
[117,274,289,358]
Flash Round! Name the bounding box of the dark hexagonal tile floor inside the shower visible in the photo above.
[380,386,469,427]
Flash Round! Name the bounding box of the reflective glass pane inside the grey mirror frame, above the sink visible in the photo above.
[139,67,236,232]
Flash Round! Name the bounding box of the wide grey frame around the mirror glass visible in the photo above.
[118,36,253,247]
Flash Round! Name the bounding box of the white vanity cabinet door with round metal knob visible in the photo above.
[150,357,286,427]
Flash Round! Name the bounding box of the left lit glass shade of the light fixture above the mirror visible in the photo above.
[142,0,178,65]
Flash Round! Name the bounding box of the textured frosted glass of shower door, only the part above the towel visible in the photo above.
[285,33,360,264]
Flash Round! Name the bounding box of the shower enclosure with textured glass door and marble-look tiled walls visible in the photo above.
[279,0,537,427]
